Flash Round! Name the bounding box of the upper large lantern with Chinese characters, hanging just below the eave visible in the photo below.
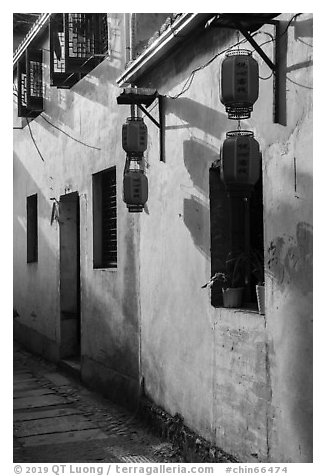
[220,50,259,120]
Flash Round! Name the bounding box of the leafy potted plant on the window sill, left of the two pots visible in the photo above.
[202,252,248,308]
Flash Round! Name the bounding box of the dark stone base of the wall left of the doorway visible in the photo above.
[13,319,60,362]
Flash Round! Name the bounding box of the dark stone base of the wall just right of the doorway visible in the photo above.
[81,355,140,410]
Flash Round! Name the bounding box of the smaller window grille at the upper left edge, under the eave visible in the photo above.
[17,48,43,117]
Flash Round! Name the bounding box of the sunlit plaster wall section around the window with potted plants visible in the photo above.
[140,14,312,462]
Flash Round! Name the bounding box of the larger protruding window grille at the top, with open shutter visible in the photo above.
[50,13,108,88]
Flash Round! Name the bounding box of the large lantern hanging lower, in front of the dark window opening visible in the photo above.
[221,130,261,190]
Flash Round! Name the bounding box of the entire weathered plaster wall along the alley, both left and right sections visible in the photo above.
[14,14,312,462]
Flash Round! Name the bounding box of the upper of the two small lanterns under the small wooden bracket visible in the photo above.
[122,117,147,156]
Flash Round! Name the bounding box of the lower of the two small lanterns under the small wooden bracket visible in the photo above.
[123,157,148,212]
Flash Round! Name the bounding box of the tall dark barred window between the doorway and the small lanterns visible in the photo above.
[93,167,117,268]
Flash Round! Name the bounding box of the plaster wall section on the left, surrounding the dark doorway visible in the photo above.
[14,14,139,403]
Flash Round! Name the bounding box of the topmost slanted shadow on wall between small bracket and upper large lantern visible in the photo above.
[166,98,228,139]
